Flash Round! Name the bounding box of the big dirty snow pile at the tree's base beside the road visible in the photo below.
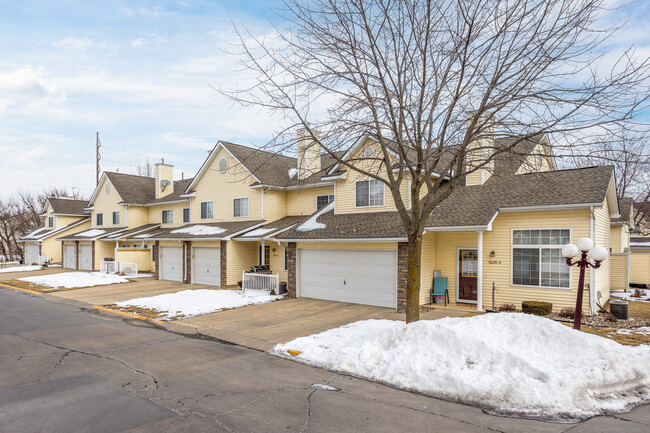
[270,313,650,422]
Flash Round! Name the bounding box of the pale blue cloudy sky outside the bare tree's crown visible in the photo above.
[0,0,650,199]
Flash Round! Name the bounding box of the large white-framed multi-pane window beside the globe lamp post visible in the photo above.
[512,229,571,288]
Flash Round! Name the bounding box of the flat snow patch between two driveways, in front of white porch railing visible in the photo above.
[116,289,282,320]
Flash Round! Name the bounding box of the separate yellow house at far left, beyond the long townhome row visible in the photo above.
[19,197,90,264]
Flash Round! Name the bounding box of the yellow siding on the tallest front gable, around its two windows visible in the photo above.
[191,148,262,223]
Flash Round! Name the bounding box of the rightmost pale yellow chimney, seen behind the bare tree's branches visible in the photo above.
[465,116,494,186]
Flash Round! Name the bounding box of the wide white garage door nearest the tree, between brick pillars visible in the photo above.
[299,249,397,308]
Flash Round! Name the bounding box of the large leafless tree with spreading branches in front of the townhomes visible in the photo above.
[220,0,648,322]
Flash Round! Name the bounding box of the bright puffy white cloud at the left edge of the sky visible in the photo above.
[0,65,66,114]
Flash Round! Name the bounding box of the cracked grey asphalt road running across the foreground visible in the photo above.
[0,287,650,433]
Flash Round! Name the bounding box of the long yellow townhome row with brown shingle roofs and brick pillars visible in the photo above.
[52,131,630,313]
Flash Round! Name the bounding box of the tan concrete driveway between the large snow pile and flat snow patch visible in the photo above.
[172,298,472,351]
